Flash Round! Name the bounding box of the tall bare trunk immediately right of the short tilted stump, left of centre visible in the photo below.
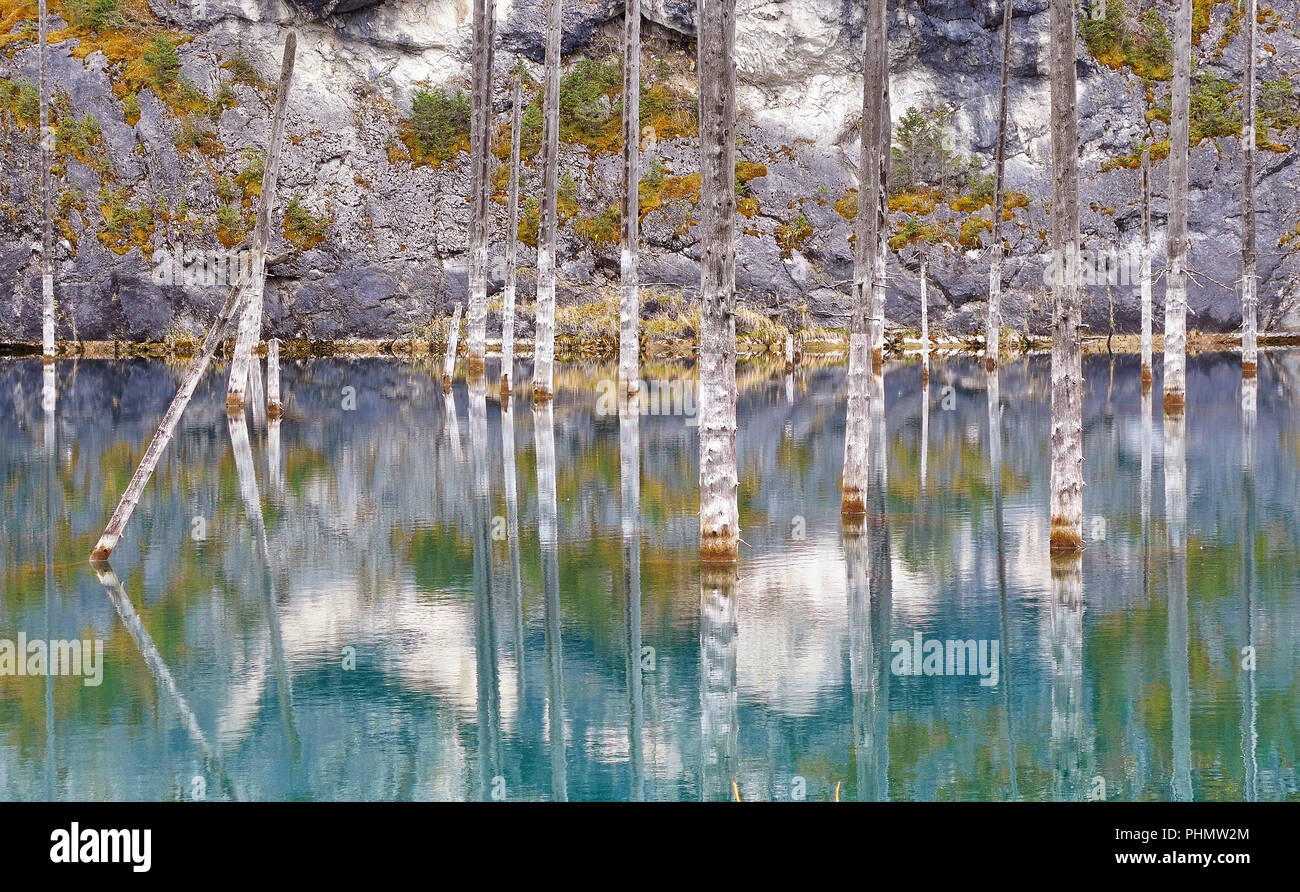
[465,0,497,377]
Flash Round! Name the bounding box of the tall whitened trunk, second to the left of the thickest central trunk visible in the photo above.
[533,0,560,399]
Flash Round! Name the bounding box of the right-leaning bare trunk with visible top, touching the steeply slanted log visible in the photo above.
[226,31,298,412]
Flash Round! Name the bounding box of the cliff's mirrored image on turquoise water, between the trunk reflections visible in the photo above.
[0,356,1300,798]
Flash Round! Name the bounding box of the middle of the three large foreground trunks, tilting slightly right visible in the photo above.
[840,0,887,518]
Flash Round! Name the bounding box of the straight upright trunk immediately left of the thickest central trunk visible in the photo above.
[619,0,641,393]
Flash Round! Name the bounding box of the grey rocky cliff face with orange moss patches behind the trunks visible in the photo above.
[0,0,1300,341]
